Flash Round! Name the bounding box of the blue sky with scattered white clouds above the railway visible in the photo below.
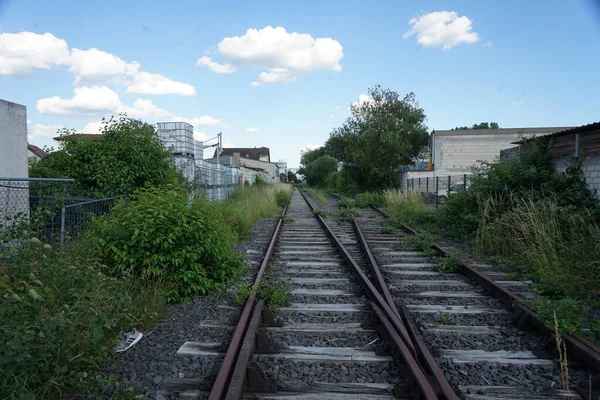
[0,0,600,167]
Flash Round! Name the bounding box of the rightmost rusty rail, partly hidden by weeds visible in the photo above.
[371,207,600,397]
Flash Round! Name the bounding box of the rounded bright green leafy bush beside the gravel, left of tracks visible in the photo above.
[88,186,243,302]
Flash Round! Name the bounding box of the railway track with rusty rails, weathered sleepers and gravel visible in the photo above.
[162,190,593,400]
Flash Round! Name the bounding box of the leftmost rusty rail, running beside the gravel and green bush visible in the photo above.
[208,206,287,400]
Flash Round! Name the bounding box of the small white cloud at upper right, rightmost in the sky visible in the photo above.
[403,11,479,50]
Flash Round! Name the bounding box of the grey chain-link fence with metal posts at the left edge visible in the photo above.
[0,178,118,244]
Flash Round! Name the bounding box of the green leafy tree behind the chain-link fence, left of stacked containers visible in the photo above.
[30,116,184,196]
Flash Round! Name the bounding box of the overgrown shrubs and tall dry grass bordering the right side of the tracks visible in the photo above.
[384,138,600,340]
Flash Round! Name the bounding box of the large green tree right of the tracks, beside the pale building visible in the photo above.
[322,86,429,190]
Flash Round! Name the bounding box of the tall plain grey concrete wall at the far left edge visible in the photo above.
[0,100,29,224]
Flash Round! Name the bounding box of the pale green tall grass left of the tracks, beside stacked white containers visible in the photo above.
[216,183,293,238]
